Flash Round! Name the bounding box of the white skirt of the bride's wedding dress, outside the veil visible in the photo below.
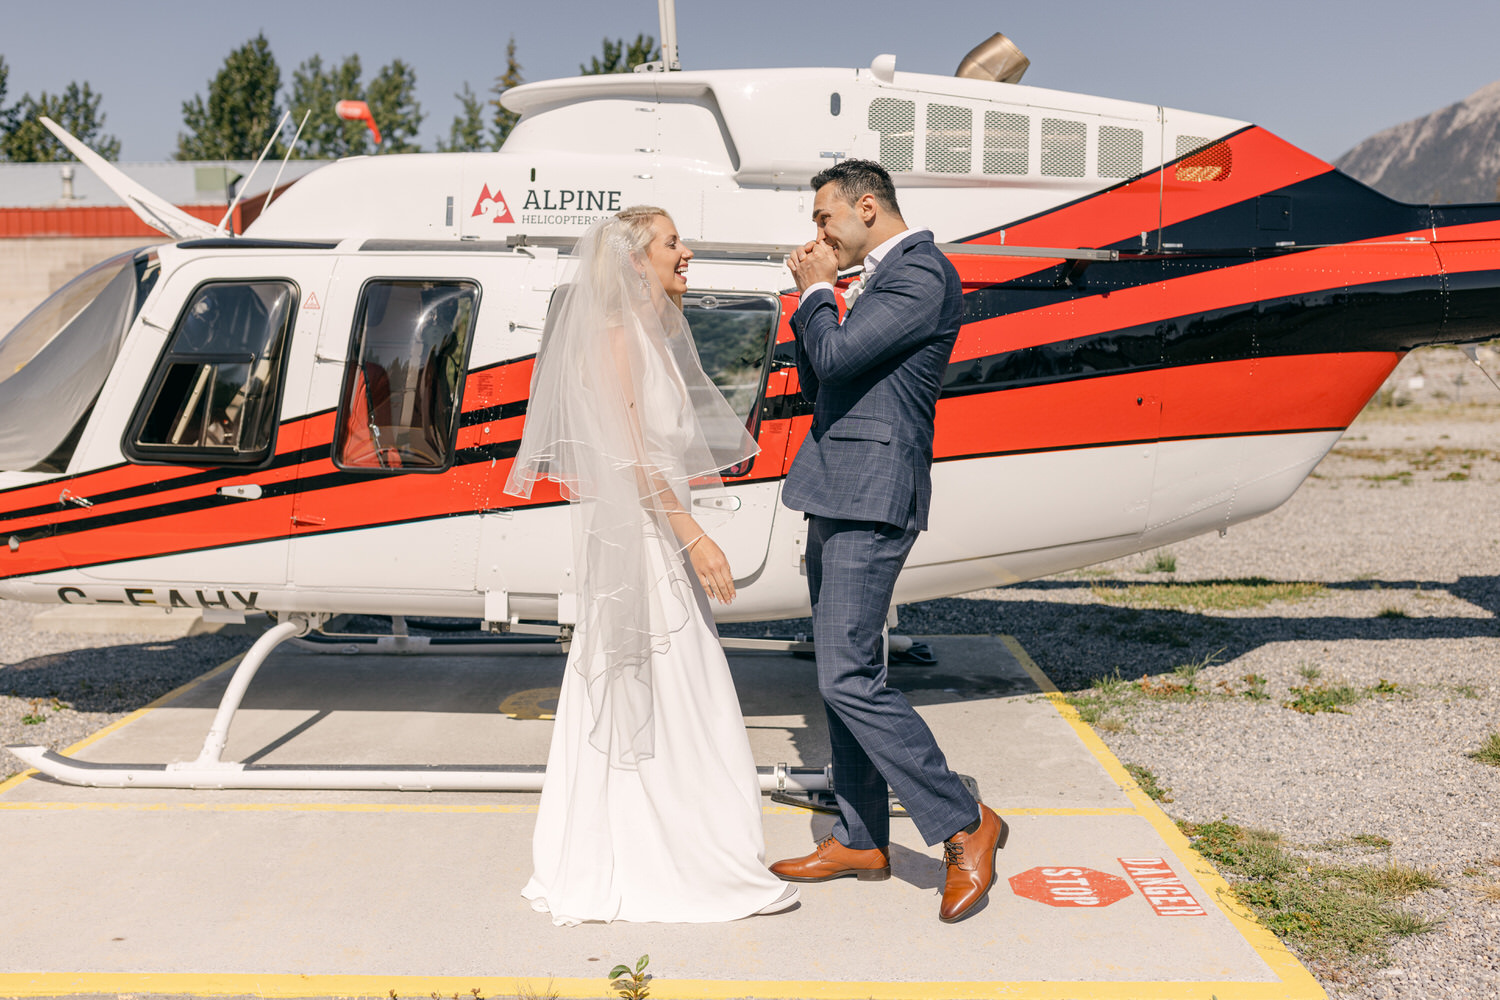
[522,512,788,925]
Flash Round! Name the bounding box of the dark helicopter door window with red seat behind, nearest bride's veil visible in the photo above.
[333,279,479,472]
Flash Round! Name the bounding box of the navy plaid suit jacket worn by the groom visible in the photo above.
[782,231,963,531]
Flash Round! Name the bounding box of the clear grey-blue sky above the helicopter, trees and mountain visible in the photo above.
[0,0,1500,160]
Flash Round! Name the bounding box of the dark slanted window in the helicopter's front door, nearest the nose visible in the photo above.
[125,280,297,465]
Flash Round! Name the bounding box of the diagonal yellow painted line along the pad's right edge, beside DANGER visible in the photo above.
[1001,636,1328,997]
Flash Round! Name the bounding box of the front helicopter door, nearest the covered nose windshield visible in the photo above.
[63,256,326,593]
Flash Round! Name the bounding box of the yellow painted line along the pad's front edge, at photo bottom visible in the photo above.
[0,963,1323,1000]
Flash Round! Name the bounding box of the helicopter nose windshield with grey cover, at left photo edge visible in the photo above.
[0,250,161,472]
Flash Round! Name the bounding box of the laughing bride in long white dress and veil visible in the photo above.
[506,207,797,925]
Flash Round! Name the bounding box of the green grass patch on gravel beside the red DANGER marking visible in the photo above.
[1179,820,1437,961]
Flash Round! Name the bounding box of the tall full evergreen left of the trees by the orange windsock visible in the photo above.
[177,34,285,160]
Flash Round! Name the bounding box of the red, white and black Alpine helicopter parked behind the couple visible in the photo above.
[0,11,1500,787]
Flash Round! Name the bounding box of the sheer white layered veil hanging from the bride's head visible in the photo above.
[506,216,759,768]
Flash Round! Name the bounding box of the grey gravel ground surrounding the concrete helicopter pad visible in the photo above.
[0,349,1500,1000]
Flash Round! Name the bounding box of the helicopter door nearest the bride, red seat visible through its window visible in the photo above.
[291,265,480,612]
